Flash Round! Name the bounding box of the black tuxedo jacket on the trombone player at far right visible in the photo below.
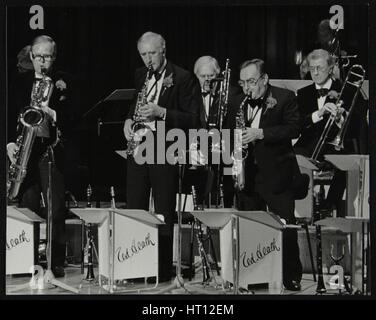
[294,80,367,157]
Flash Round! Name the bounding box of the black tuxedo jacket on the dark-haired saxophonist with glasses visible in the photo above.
[228,85,299,193]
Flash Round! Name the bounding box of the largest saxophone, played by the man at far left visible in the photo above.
[7,69,53,200]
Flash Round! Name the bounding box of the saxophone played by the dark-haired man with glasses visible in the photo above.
[232,95,249,191]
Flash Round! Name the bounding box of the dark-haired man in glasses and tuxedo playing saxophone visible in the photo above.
[227,59,302,291]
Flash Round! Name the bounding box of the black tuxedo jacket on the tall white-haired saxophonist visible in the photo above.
[127,61,201,131]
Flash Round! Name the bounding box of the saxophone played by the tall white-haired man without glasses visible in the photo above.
[125,64,153,156]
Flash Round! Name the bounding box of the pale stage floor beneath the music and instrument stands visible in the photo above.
[6,265,317,295]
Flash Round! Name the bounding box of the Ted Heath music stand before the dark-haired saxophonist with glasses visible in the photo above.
[192,209,285,294]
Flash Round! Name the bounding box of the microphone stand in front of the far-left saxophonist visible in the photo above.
[43,146,79,293]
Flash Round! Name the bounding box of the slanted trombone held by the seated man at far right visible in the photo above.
[311,64,366,162]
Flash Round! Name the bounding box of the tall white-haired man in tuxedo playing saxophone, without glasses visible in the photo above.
[124,32,199,282]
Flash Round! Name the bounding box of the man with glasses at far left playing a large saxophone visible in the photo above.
[7,35,75,277]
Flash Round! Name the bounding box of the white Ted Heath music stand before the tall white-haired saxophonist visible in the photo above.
[71,208,164,293]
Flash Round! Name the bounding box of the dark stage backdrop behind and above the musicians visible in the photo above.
[7,1,368,201]
